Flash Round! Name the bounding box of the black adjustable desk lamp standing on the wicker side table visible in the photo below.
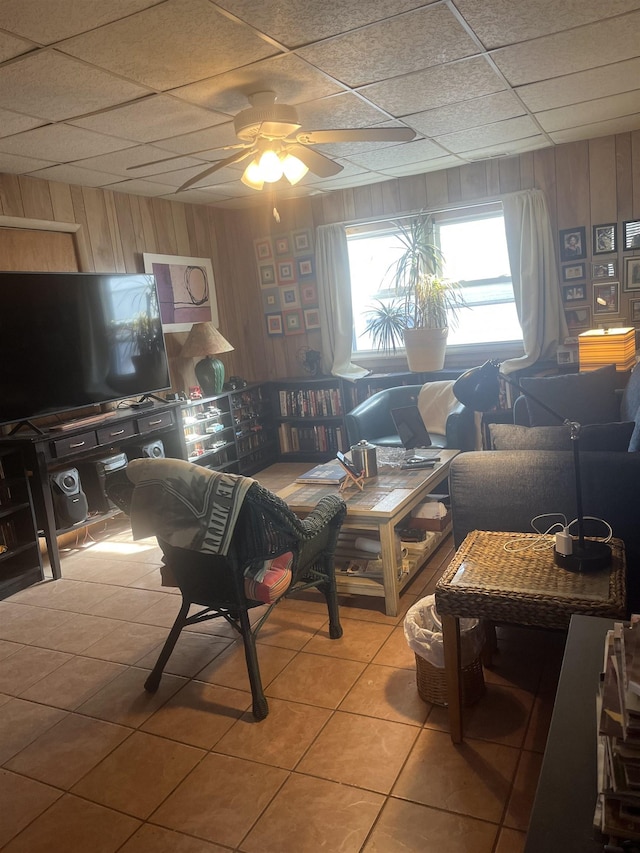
[453,361,611,572]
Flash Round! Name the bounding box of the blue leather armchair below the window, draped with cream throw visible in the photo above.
[345,383,476,450]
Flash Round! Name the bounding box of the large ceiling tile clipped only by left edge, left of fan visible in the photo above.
[0,49,147,121]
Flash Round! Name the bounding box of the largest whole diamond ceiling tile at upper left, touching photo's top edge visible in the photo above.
[59,0,278,91]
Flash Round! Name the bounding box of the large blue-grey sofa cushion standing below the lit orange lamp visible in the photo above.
[520,364,619,426]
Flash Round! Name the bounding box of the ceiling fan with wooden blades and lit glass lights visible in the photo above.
[129,91,416,192]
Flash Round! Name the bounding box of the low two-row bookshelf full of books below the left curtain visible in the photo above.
[272,376,351,462]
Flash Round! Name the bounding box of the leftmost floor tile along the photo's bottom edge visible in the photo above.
[3,794,140,853]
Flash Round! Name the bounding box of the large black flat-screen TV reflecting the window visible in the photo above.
[0,272,170,423]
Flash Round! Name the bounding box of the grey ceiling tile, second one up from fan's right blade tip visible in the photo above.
[358,56,507,116]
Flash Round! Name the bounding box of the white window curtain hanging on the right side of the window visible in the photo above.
[500,190,569,373]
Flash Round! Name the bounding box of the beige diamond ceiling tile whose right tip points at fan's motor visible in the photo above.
[69,95,228,142]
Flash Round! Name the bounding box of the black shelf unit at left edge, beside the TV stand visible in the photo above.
[0,449,44,598]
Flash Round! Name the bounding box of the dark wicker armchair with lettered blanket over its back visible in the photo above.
[107,459,346,720]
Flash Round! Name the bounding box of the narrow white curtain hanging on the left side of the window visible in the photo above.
[316,225,371,381]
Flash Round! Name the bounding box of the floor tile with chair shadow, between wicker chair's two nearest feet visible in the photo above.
[141,681,253,749]
